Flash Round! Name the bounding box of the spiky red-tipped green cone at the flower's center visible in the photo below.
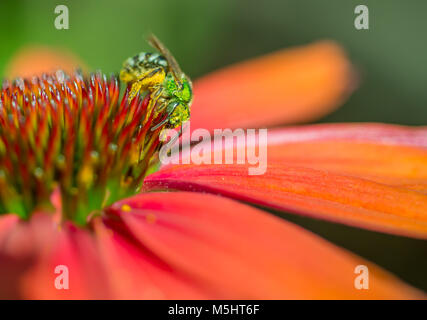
[0,71,172,225]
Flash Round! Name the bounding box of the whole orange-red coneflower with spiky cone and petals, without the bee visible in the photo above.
[0,42,427,299]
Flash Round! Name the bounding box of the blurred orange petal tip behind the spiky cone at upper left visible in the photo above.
[5,46,85,79]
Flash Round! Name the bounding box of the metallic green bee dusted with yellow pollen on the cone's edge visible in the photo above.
[120,35,193,129]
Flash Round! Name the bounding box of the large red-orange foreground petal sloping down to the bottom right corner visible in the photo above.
[111,192,424,299]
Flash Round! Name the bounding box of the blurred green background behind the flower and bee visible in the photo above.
[0,0,427,291]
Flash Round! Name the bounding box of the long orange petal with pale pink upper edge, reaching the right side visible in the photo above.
[145,125,427,238]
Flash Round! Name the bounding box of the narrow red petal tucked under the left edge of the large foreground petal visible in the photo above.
[95,213,208,300]
